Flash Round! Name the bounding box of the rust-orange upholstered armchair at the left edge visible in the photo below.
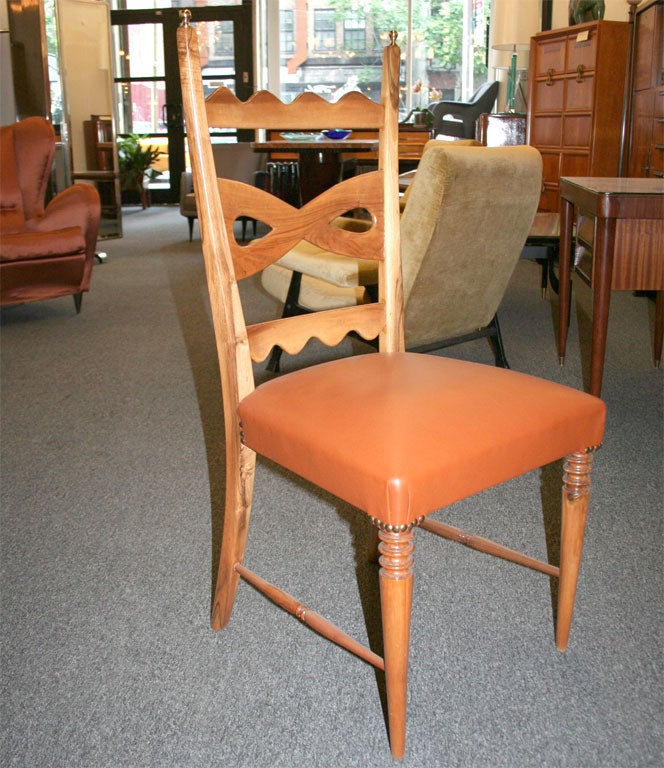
[0,117,100,312]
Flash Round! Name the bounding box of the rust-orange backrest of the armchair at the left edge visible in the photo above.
[0,117,55,234]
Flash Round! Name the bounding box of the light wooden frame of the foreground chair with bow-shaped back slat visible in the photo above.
[178,11,604,758]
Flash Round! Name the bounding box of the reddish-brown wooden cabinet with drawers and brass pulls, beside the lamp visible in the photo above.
[527,21,629,211]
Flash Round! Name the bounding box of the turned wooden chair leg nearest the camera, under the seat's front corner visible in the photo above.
[378,530,414,759]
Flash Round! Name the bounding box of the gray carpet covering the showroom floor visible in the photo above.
[0,208,664,768]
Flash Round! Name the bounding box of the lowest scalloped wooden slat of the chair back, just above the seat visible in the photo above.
[247,302,385,363]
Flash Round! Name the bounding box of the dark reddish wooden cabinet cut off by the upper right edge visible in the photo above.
[627,0,664,179]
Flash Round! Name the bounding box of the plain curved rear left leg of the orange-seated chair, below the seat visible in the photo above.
[212,438,256,630]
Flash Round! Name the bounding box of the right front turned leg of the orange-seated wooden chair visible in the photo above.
[556,452,593,651]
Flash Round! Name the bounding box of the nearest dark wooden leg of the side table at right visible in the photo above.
[590,217,616,397]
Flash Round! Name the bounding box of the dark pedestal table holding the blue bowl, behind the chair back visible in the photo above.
[251,138,378,205]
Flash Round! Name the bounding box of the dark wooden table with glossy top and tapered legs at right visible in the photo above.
[558,177,664,396]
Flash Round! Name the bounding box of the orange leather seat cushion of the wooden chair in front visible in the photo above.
[238,353,605,526]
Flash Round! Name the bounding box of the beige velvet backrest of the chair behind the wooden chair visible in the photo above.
[401,140,542,347]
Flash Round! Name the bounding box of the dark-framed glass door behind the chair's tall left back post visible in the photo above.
[111,5,254,203]
